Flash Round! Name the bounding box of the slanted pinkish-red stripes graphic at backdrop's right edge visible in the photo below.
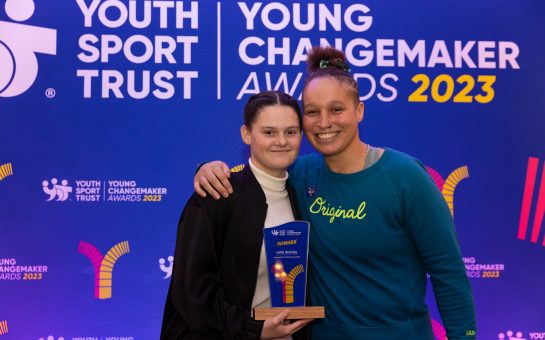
[517,157,545,246]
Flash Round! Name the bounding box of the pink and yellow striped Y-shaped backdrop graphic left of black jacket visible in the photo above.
[78,241,130,299]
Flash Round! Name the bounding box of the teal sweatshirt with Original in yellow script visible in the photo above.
[289,149,475,340]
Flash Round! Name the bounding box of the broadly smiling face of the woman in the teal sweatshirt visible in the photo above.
[303,77,363,160]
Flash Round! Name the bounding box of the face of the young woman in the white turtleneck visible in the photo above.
[240,104,301,177]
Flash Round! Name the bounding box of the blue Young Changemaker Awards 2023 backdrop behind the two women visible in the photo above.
[0,0,545,340]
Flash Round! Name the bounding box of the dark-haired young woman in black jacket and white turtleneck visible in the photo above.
[161,91,311,340]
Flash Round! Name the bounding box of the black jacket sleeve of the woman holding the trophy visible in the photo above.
[172,196,263,339]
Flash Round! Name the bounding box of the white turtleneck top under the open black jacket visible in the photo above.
[248,159,295,308]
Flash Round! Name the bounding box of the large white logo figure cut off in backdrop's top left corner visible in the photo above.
[0,0,57,97]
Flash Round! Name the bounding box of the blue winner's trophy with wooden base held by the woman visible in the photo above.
[253,221,325,320]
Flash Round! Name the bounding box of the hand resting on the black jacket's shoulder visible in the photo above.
[193,161,233,200]
